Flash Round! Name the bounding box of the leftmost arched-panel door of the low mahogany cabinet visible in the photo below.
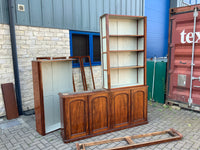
[65,96,88,139]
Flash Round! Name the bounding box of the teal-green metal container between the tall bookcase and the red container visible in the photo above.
[147,60,167,104]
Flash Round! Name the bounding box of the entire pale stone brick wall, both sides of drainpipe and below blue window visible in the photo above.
[0,24,102,116]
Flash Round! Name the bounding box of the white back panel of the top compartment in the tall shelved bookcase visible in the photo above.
[109,17,137,35]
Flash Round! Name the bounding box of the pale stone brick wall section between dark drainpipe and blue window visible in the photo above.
[15,26,70,110]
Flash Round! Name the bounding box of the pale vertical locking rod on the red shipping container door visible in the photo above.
[188,7,198,107]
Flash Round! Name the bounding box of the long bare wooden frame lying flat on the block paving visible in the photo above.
[76,128,183,150]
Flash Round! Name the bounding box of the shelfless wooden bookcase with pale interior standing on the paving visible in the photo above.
[32,59,73,135]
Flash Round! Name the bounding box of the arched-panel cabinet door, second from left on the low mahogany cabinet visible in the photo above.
[89,92,110,134]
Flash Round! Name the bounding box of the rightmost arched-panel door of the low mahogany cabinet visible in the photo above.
[130,86,147,124]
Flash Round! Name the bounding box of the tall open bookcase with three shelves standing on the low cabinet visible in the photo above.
[100,14,146,89]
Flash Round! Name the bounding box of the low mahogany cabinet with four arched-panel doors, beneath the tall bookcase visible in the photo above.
[59,86,148,143]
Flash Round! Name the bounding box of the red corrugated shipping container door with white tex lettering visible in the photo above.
[167,12,200,105]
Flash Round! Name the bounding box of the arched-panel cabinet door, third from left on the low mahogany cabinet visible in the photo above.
[111,90,130,128]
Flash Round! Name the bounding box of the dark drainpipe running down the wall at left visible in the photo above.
[8,0,23,115]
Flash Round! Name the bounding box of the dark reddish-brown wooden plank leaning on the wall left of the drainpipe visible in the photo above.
[1,83,19,120]
